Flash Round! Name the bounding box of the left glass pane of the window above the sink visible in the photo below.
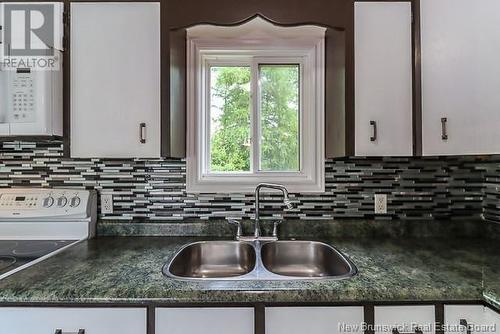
[210,66,251,172]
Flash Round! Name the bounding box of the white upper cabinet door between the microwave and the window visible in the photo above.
[71,2,160,158]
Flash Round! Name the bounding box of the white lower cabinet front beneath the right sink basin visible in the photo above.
[266,306,364,334]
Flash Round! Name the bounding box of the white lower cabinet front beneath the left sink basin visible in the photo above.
[155,307,254,334]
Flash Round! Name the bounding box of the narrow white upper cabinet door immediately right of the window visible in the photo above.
[355,2,413,156]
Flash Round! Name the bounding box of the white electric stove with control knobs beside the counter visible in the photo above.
[0,188,97,279]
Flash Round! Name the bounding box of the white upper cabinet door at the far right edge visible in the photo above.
[421,0,500,155]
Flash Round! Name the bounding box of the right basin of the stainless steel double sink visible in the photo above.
[261,241,357,278]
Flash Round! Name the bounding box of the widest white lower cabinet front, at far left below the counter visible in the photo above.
[0,307,147,334]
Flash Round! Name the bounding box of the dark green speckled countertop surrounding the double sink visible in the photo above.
[0,237,500,303]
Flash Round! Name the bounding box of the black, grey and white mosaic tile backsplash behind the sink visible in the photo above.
[0,141,500,221]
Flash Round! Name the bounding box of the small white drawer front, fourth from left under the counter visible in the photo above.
[375,305,435,334]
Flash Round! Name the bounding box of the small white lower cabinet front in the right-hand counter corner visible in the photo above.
[444,305,485,334]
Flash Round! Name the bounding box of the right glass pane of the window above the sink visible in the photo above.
[259,65,300,171]
